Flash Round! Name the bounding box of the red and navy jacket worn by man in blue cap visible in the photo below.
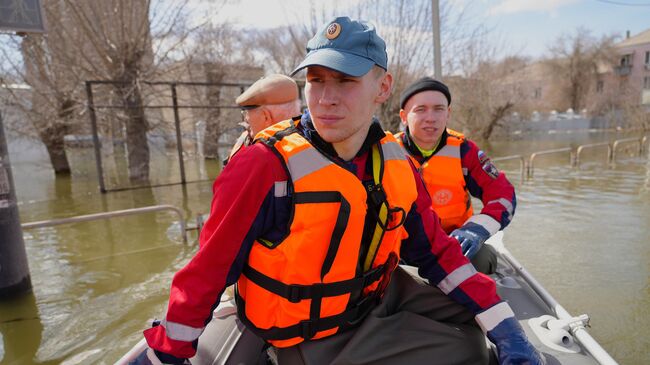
[144,114,501,358]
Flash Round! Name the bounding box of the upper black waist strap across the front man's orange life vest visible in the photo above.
[243,265,387,303]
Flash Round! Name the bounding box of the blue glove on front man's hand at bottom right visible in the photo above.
[487,317,546,365]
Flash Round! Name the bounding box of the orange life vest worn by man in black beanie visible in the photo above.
[397,129,474,233]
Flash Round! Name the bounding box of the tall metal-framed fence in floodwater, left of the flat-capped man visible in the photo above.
[82,80,258,193]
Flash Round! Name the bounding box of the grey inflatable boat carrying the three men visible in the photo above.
[116,232,617,365]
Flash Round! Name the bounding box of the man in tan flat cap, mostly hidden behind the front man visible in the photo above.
[223,74,300,166]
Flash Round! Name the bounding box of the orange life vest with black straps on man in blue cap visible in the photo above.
[235,121,417,347]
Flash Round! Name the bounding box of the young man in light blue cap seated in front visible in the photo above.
[133,17,543,365]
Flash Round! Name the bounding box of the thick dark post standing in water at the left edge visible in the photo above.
[0,114,32,300]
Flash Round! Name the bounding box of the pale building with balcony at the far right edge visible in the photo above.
[613,29,650,105]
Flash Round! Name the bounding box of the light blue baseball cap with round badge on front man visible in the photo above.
[291,17,388,77]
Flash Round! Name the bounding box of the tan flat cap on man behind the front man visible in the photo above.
[235,74,298,108]
